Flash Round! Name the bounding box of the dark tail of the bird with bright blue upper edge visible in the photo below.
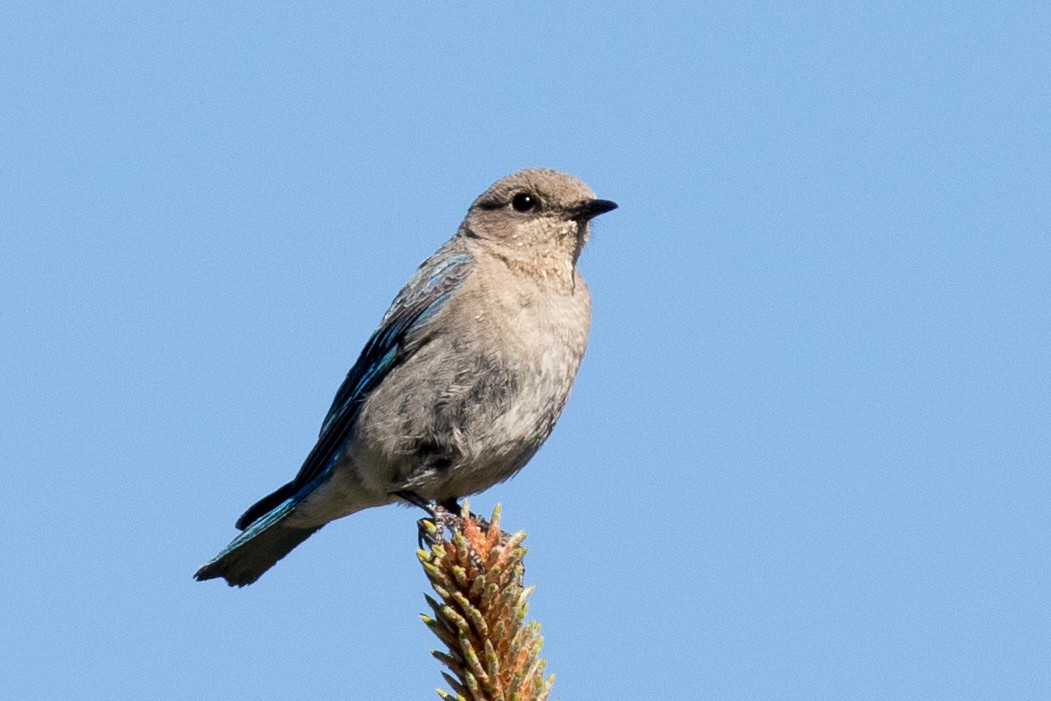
[193,497,322,586]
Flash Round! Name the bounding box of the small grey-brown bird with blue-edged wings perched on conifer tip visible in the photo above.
[194,168,617,586]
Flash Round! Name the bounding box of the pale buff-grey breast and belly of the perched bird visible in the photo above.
[352,265,590,499]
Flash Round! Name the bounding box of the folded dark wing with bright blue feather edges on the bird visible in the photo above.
[292,252,474,491]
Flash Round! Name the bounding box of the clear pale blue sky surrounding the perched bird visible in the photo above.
[0,2,1051,701]
